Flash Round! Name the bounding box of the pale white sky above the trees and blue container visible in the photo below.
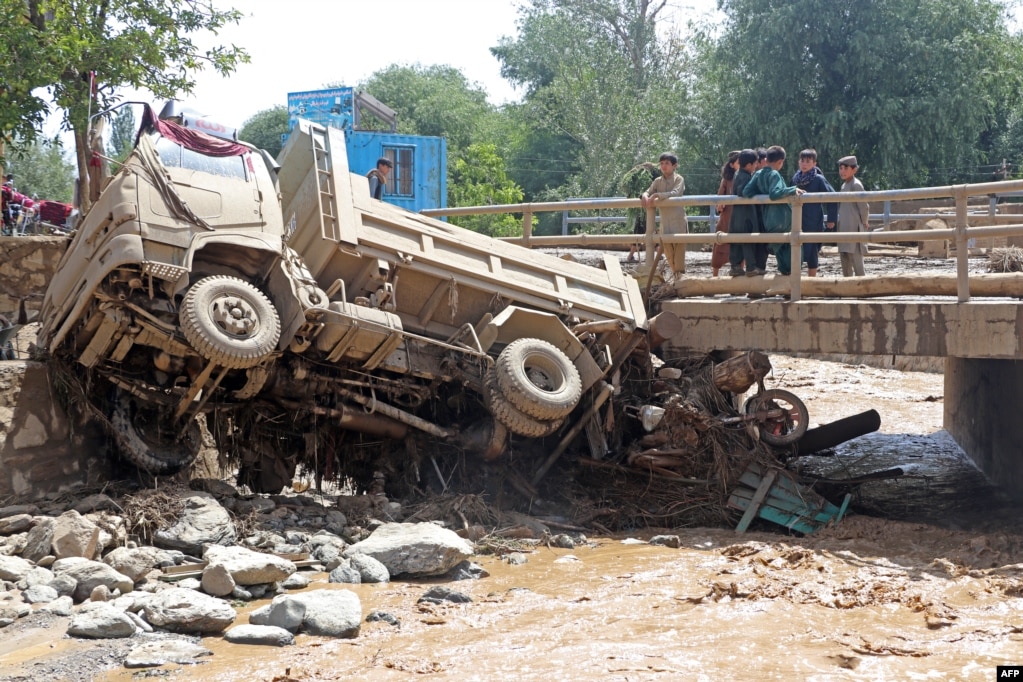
[112,0,716,127]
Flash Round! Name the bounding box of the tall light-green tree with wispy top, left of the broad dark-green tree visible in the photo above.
[491,0,690,196]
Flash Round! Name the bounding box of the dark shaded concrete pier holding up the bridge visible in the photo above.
[943,357,1023,490]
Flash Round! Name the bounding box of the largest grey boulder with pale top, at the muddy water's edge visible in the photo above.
[345,524,473,578]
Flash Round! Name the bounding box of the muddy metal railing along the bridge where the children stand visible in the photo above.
[421,180,1023,302]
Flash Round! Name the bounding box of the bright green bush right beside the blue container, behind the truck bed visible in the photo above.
[450,144,523,237]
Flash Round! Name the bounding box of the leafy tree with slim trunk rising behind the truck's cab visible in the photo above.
[15,0,248,210]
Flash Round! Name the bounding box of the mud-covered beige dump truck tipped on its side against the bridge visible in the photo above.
[39,109,662,492]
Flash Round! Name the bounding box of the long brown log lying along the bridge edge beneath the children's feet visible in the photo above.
[673,273,1023,299]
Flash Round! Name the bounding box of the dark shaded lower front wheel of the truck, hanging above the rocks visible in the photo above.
[110,392,203,475]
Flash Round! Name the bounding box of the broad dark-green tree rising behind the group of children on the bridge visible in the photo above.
[702,0,1023,186]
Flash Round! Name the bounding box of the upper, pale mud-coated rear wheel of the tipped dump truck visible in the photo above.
[496,338,582,420]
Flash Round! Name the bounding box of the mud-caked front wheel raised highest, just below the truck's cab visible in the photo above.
[178,275,280,369]
